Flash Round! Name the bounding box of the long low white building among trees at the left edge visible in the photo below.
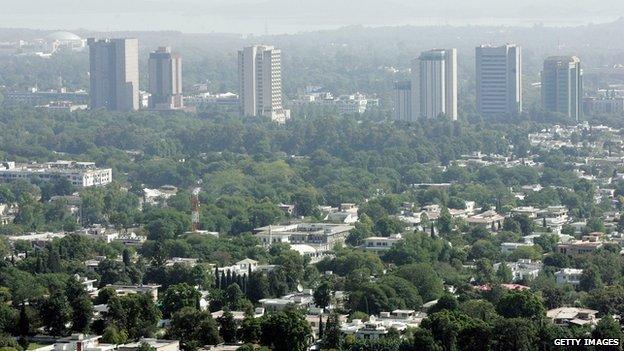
[0,161,113,188]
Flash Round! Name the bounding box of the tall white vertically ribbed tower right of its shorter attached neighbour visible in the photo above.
[412,49,457,120]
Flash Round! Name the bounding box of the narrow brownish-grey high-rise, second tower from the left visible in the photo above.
[148,47,183,110]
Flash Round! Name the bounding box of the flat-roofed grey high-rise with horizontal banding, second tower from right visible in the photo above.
[475,44,522,116]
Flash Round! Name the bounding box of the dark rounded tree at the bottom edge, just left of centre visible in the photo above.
[260,309,312,351]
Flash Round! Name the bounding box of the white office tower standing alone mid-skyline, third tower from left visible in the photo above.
[238,45,290,123]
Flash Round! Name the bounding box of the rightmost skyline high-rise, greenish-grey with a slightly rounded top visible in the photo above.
[542,56,583,121]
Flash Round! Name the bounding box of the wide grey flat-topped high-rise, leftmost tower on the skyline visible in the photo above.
[87,38,139,111]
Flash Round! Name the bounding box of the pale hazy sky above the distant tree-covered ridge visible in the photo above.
[0,0,624,34]
